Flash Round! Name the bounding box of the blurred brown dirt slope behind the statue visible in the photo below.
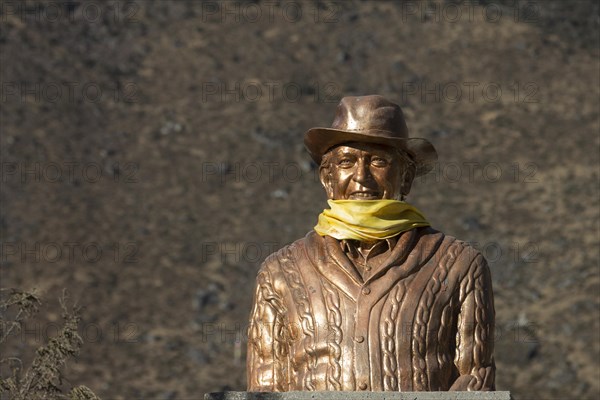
[0,1,600,399]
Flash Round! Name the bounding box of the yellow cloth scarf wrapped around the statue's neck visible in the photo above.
[315,200,430,240]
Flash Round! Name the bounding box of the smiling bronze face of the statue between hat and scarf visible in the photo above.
[321,143,405,200]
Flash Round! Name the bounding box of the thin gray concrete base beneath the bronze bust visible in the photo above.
[204,392,512,400]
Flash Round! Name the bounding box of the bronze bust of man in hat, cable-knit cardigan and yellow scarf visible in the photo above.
[247,96,495,392]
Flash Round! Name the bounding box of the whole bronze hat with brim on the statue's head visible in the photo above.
[304,95,437,176]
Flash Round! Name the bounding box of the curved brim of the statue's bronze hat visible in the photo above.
[304,128,438,176]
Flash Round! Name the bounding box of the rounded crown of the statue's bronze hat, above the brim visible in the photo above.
[331,95,408,139]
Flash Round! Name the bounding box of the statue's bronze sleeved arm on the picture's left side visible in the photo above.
[246,268,289,392]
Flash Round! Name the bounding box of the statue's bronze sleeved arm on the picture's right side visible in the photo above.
[450,253,496,391]
